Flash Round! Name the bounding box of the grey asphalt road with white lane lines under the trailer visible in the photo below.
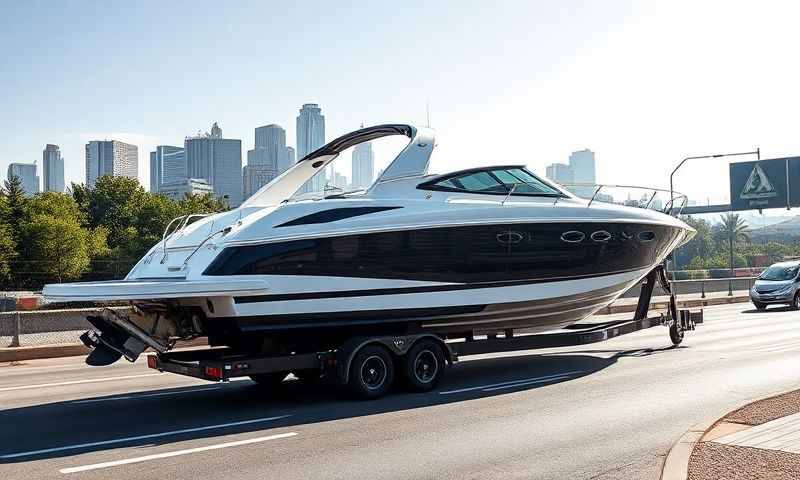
[0,304,800,480]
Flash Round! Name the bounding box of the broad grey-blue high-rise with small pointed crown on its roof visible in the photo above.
[184,123,242,207]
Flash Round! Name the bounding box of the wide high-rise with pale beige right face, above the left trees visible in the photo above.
[86,140,139,187]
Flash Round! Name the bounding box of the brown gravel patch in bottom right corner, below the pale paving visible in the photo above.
[688,442,800,480]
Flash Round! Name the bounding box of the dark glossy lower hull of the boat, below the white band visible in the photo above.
[228,281,633,334]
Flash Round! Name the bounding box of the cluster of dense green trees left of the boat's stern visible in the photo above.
[0,176,227,288]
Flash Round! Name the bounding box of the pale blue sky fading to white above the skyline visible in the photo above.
[0,0,800,210]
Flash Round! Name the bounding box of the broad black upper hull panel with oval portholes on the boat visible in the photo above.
[203,222,683,286]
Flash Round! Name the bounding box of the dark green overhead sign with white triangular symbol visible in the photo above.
[729,157,800,210]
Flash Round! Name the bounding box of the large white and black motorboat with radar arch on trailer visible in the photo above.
[43,124,694,365]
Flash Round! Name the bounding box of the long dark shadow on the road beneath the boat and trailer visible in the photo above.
[0,347,675,464]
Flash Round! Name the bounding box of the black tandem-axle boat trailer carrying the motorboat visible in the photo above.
[147,266,703,398]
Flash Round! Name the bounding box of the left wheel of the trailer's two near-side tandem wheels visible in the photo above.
[347,345,394,399]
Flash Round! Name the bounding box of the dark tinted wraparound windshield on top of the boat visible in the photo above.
[418,167,564,196]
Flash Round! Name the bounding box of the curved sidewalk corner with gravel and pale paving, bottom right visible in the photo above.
[662,390,800,480]
